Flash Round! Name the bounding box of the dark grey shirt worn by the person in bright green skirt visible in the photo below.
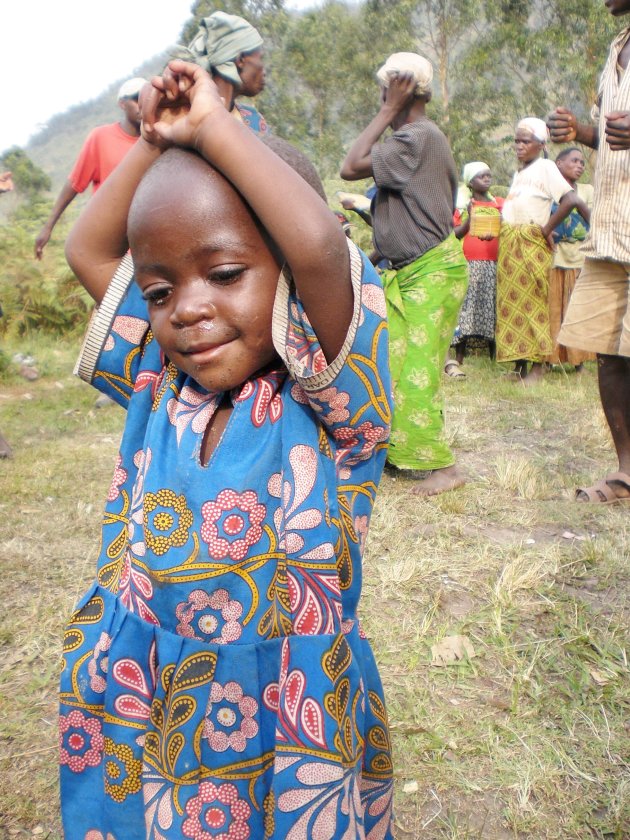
[372,117,457,268]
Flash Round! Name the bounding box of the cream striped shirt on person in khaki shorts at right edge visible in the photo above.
[582,27,630,263]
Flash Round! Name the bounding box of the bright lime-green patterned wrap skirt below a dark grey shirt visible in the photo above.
[382,234,468,470]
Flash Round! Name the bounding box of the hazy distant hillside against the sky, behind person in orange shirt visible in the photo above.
[25,52,168,195]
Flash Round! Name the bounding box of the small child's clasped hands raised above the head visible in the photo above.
[142,59,226,148]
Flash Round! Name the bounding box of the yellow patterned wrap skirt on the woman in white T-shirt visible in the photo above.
[496,222,553,362]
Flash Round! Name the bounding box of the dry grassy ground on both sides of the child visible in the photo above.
[0,342,630,840]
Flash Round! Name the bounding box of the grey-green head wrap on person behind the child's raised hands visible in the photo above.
[173,12,263,87]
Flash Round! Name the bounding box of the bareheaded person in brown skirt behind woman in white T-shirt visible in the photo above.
[547,146,595,373]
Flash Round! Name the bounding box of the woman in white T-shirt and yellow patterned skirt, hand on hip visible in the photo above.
[496,117,579,385]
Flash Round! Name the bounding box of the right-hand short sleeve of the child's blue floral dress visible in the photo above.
[273,240,392,463]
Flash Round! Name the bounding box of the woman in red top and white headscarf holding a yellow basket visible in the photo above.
[444,161,503,378]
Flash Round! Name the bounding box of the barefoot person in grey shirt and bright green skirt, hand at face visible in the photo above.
[341,53,468,496]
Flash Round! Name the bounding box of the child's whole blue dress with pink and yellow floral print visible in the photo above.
[60,242,392,840]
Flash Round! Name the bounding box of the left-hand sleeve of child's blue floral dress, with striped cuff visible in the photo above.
[74,254,164,408]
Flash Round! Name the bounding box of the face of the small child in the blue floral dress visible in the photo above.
[128,160,280,391]
